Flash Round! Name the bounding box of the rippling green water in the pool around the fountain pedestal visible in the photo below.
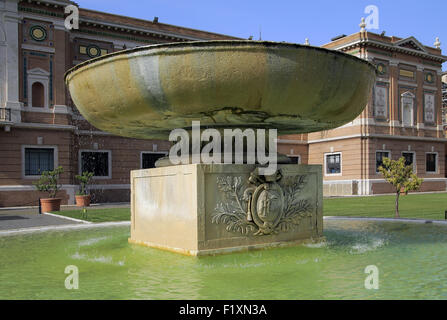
[0,220,447,299]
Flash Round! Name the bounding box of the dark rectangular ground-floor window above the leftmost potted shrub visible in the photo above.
[25,148,54,176]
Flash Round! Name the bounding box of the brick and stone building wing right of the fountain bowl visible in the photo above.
[304,30,447,196]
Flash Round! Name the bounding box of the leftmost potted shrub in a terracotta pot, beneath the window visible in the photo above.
[33,167,64,212]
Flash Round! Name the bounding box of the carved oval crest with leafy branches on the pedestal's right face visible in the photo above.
[212,169,313,236]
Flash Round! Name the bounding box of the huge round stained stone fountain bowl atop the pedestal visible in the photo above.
[65,41,376,138]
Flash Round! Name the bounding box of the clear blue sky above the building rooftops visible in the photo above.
[76,0,447,70]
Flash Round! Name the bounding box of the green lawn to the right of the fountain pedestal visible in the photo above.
[323,193,447,220]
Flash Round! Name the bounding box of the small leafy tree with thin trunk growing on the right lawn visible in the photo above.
[379,157,423,218]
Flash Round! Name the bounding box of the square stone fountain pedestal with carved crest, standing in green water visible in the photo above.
[129,164,323,256]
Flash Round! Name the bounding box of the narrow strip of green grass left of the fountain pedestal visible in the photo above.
[53,208,130,223]
